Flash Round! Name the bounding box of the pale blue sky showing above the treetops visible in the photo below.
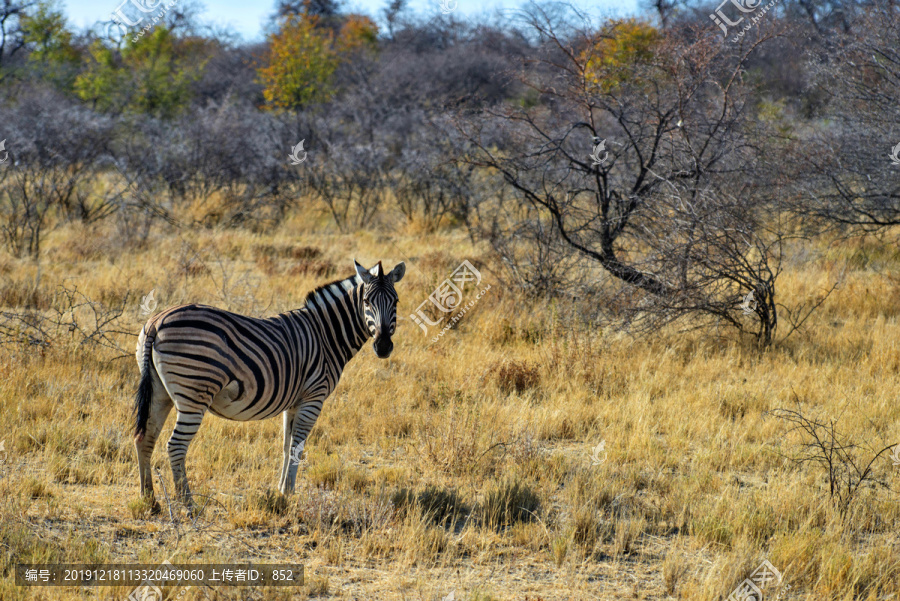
[60,0,638,41]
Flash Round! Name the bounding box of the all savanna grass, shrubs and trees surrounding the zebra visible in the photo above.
[0,0,900,601]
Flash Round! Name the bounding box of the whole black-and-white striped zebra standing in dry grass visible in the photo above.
[134,261,406,511]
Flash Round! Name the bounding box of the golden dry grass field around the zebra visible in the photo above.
[0,204,900,601]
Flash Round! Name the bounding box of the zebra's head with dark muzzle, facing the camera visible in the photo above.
[353,261,406,359]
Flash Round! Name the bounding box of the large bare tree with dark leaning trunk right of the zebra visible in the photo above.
[460,8,808,344]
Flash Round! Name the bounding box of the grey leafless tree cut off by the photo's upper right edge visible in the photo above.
[784,2,900,234]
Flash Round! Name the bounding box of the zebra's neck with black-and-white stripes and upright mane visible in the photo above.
[304,276,371,363]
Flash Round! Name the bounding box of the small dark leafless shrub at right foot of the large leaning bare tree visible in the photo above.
[623,190,838,346]
